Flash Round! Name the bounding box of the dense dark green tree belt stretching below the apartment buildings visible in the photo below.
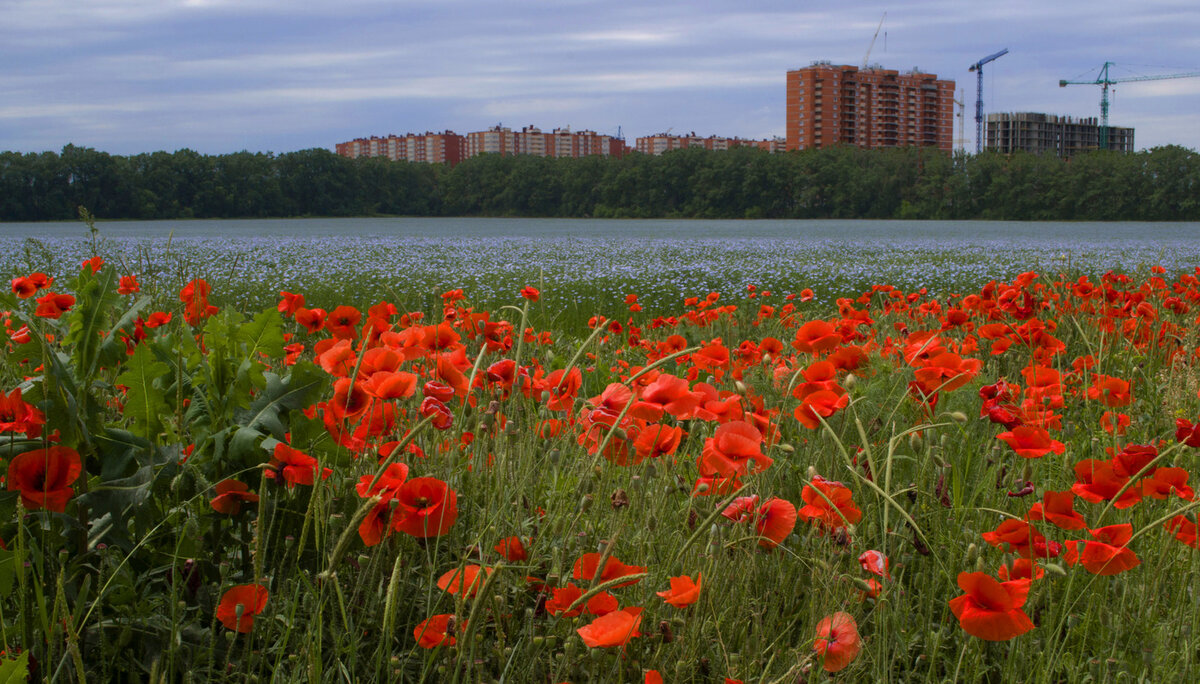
[0,145,1200,221]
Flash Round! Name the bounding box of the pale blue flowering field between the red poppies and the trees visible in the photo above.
[0,218,1200,305]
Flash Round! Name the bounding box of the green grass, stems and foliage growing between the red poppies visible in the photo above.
[0,220,1200,682]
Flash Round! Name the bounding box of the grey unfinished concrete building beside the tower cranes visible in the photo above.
[986,112,1133,158]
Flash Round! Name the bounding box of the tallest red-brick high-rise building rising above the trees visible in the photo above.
[786,62,954,152]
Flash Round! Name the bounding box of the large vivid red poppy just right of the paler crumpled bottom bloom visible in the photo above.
[950,572,1033,641]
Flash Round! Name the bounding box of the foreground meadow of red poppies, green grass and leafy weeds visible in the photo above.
[0,219,1200,683]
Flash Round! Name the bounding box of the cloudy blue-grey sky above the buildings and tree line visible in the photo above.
[0,0,1200,155]
